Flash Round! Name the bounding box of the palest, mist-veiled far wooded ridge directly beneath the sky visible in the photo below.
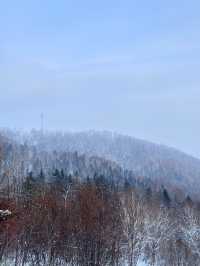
[4,130,200,199]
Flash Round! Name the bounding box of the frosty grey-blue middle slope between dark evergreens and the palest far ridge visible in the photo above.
[0,136,153,198]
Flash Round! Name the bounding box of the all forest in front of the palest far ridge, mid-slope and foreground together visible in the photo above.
[0,132,200,266]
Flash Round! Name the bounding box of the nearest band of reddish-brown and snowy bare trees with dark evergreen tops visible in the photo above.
[0,169,200,266]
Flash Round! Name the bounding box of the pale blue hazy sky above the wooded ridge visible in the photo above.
[0,0,200,157]
